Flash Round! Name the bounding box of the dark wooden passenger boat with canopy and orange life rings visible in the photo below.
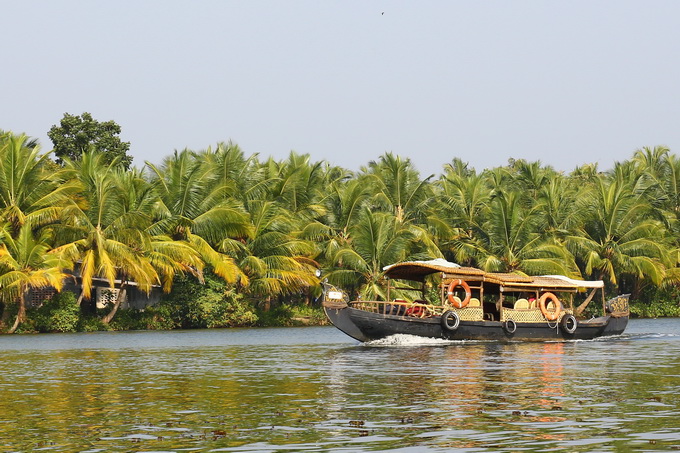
[323,259,629,342]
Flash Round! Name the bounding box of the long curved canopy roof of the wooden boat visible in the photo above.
[383,258,604,291]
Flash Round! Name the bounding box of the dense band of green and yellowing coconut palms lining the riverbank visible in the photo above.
[0,123,680,331]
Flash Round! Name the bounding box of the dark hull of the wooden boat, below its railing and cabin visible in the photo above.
[324,306,628,342]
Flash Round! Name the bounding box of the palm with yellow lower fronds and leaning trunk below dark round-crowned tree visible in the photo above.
[54,152,159,322]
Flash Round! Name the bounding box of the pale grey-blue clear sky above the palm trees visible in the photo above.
[0,0,680,176]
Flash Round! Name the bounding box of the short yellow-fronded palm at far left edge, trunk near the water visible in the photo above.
[0,223,66,333]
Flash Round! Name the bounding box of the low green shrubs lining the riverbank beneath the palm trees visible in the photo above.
[12,273,680,332]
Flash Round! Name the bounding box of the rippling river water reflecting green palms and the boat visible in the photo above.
[0,319,680,452]
